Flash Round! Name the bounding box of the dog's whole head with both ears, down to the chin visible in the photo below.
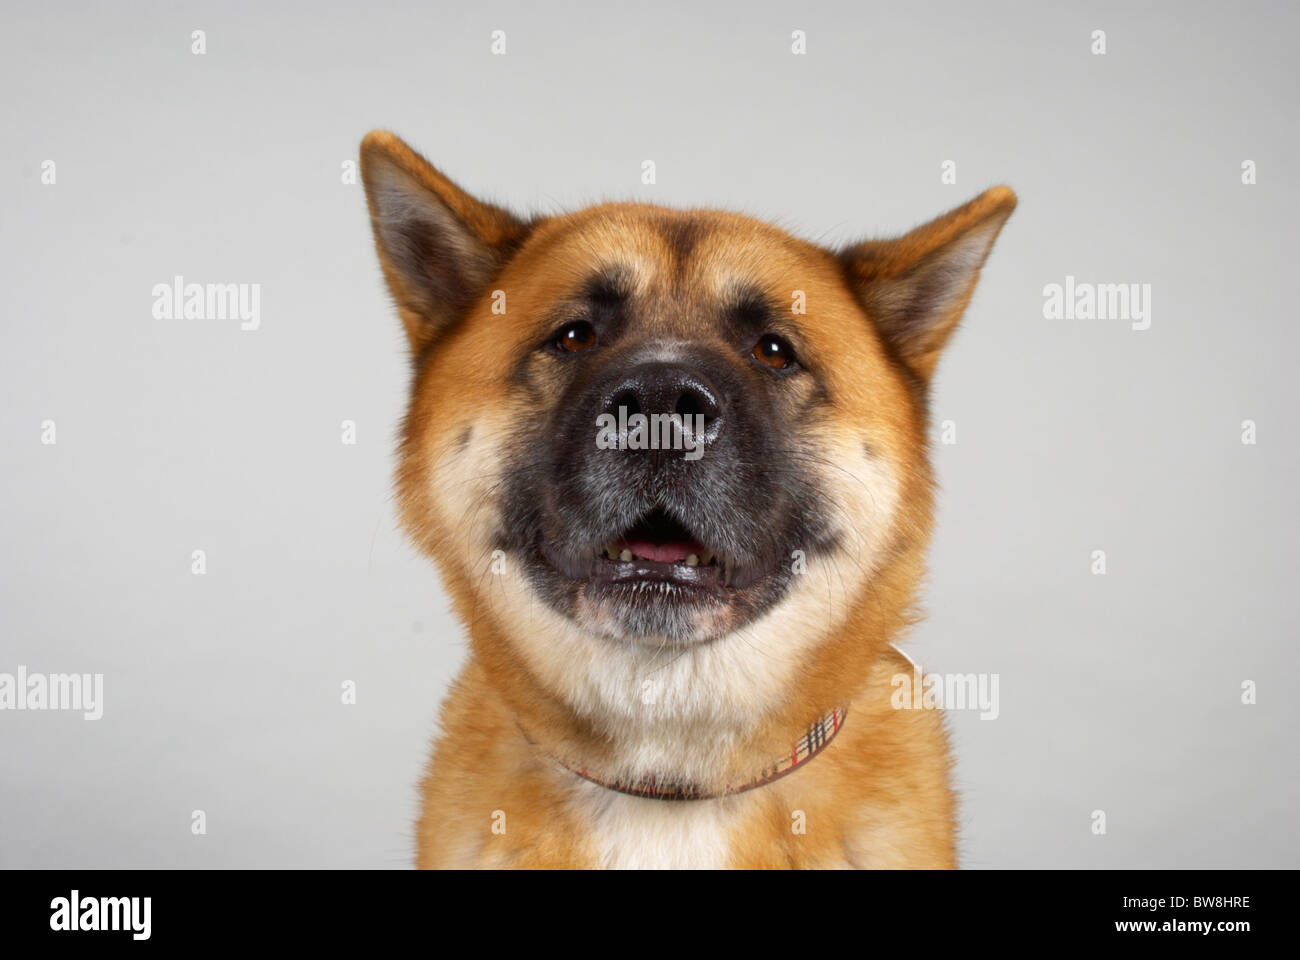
[363,134,1015,718]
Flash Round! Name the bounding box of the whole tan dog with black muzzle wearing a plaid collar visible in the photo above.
[361,131,1017,869]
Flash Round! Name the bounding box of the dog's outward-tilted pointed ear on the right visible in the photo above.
[840,186,1015,381]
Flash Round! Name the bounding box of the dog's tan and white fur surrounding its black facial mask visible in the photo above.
[363,133,1015,868]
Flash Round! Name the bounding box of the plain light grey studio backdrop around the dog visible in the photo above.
[0,0,1300,868]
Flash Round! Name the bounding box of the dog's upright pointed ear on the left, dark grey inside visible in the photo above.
[361,130,528,356]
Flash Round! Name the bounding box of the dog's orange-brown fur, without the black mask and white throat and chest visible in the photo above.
[361,133,1015,868]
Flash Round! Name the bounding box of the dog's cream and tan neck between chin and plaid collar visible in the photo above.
[471,561,920,795]
